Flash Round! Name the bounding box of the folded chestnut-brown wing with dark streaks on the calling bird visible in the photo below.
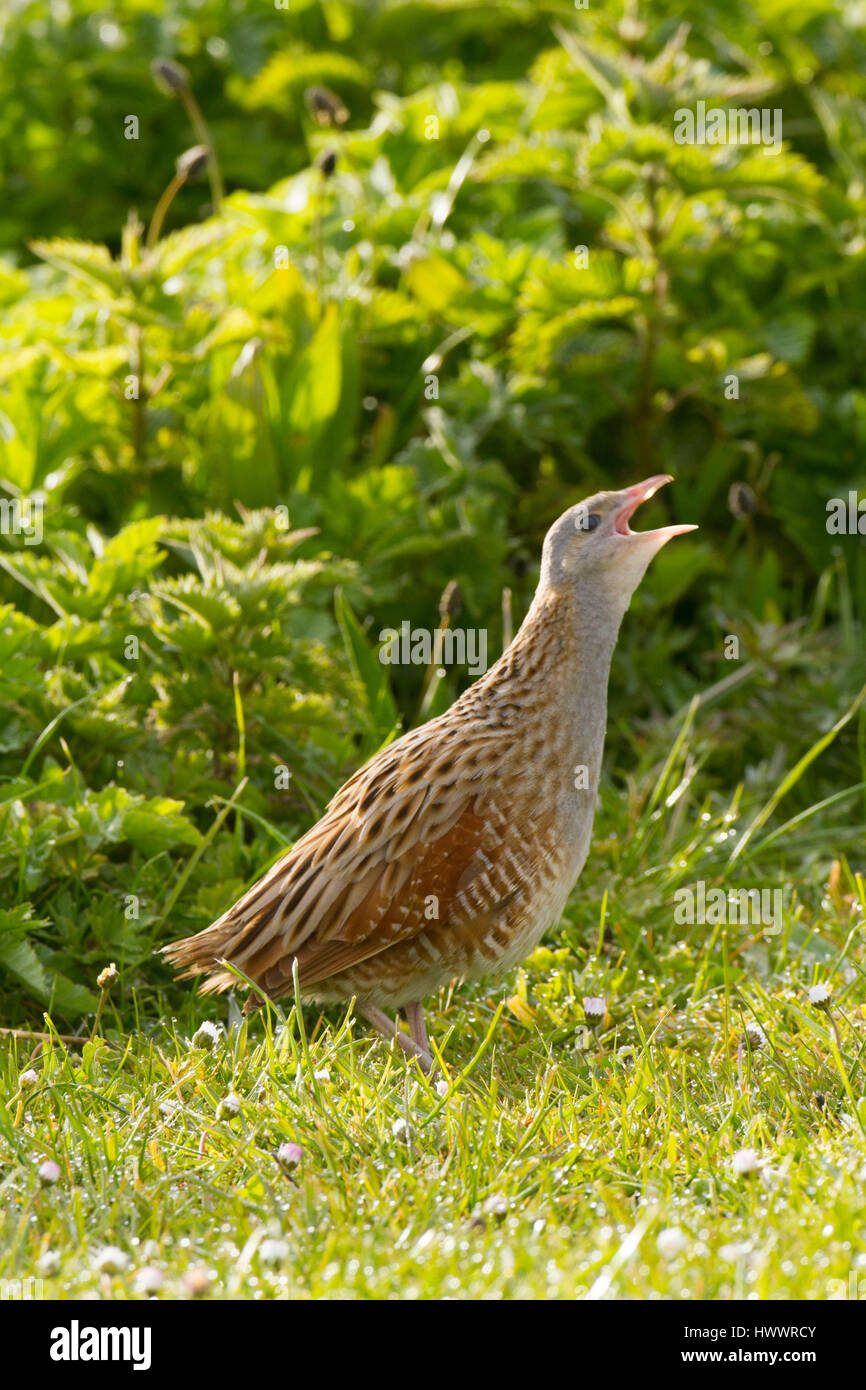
[161,724,538,997]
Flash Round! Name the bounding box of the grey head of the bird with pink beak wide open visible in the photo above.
[541,473,696,612]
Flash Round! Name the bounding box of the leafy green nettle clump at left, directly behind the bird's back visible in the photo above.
[0,513,375,1016]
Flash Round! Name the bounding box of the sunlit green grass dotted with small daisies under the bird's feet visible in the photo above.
[0,700,866,1300]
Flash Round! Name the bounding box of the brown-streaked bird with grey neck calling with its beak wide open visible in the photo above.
[163,474,695,1074]
